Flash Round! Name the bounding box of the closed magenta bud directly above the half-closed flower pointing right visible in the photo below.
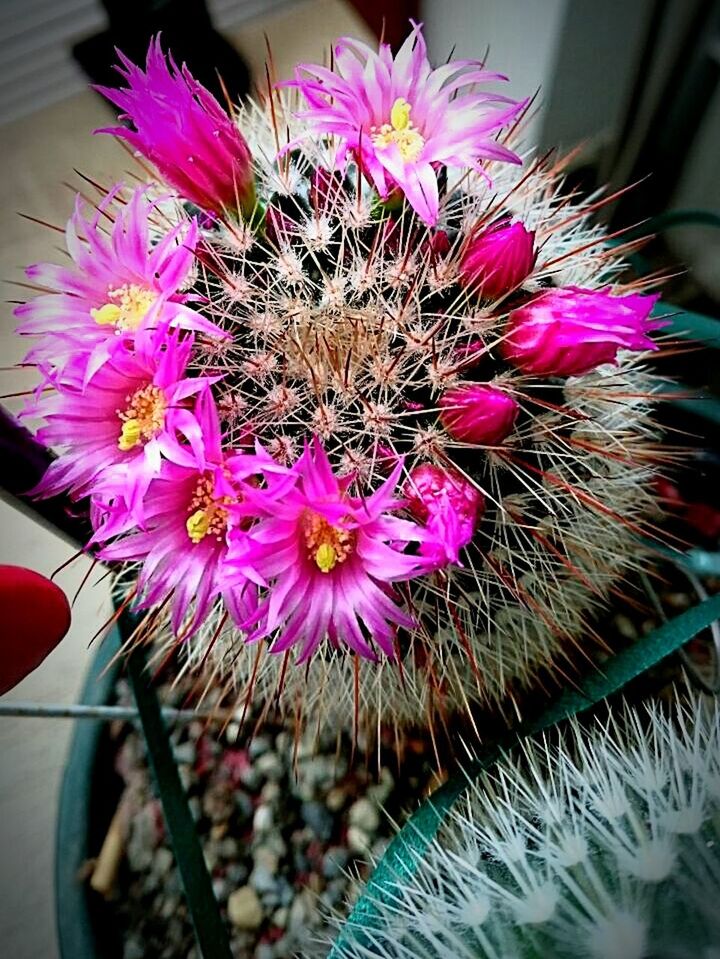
[460,220,537,300]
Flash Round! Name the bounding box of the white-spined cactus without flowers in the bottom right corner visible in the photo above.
[337,699,720,959]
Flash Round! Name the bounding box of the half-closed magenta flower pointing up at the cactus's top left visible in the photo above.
[95,37,255,216]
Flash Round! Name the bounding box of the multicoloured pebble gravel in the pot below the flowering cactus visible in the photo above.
[102,682,432,959]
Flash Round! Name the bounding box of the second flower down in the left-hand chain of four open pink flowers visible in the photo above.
[24,330,212,523]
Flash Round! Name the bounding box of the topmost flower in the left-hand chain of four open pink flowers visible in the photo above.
[15,186,227,377]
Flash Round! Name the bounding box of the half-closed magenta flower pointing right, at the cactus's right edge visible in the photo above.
[501,286,665,376]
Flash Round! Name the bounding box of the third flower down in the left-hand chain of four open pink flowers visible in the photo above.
[95,390,259,637]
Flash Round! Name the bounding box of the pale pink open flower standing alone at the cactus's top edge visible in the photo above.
[291,23,525,226]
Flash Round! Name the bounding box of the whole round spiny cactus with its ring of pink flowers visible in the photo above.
[17,25,659,736]
